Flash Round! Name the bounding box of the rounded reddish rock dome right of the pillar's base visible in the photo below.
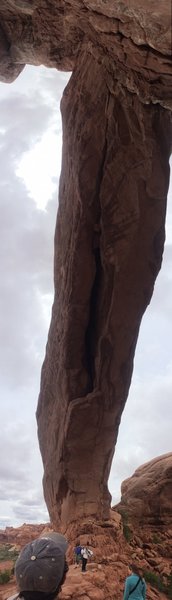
[115,453,172,530]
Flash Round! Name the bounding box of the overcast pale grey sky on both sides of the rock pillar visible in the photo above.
[0,66,172,528]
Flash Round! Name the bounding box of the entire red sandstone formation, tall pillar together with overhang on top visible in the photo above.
[0,0,172,528]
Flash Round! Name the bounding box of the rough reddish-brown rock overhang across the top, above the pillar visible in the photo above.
[0,0,172,107]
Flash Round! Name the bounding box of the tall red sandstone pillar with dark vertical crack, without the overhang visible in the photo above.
[37,54,170,525]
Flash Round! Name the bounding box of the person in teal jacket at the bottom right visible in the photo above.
[123,564,146,600]
